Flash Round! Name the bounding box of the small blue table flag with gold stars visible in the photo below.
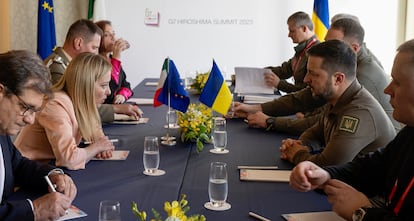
[157,59,190,113]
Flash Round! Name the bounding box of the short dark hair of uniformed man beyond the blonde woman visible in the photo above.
[65,19,102,42]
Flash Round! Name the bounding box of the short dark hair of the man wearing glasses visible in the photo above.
[0,50,52,97]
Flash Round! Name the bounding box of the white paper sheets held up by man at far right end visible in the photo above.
[234,67,274,94]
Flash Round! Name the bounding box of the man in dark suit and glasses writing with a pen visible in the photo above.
[0,51,77,221]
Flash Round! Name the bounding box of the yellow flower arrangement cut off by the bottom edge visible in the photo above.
[132,194,206,221]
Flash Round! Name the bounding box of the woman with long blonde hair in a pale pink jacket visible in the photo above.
[14,53,114,170]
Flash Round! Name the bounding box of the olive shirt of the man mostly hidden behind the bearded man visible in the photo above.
[261,44,402,134]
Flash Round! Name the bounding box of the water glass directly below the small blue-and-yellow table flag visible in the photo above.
[210,117,229,154]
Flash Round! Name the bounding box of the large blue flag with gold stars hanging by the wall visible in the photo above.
[37,0,56,59]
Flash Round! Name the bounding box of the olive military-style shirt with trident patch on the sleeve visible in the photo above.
[293,80,396,166]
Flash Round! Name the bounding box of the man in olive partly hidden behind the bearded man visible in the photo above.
[235,18,401,135]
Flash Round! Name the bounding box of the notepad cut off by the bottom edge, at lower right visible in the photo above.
[282,211,345,221]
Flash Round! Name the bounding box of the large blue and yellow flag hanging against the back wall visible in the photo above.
[312,0,329,41]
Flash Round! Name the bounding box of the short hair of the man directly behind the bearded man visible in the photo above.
[330,18,365,45]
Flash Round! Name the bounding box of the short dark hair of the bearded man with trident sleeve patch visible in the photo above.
[307,40,357,80]
